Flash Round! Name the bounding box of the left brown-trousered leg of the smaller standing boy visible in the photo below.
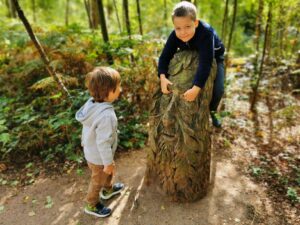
[86,162,108,206]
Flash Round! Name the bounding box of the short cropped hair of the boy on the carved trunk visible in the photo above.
[172,1,197,21]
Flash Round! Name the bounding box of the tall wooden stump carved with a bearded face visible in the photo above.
[146,51,216,201]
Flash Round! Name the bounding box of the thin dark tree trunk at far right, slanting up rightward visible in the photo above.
[250,3,272,111]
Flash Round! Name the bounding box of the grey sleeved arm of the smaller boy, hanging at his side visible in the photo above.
[96,116,114,166]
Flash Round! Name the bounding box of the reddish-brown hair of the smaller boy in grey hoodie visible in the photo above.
[85,67,121,102]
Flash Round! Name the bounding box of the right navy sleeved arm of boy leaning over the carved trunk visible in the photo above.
[193,29,214,89]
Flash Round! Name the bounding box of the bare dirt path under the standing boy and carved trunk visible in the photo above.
[0,148,281,225]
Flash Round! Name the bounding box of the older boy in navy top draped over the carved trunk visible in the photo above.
[158,1,225,127]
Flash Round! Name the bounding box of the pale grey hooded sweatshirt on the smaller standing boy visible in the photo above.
[76,98,118,166]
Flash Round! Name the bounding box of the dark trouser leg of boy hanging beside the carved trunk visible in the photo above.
[209,61,224,111]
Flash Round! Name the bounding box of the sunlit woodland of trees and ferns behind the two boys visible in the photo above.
[0,0,300,222]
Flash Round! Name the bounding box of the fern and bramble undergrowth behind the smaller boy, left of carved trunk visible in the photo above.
[0,26,157,163]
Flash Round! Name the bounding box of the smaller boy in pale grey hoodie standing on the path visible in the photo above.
[76,67,124,217]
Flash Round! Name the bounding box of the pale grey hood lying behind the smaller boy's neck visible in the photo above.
[75,98,113,126]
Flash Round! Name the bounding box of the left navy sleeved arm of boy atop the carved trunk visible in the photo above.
[158,31,177,77]
